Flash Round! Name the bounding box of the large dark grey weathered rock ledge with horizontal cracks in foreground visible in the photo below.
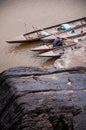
[0,67,86,130]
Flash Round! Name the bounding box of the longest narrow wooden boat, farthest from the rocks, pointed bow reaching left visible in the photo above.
[6,17,86,43]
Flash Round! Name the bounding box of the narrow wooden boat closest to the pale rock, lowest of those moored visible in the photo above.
[38,33,86,57]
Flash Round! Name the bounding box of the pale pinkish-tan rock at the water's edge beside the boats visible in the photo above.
[54,40,86,68]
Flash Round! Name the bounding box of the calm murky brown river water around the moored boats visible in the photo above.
[0,0,86,72]
